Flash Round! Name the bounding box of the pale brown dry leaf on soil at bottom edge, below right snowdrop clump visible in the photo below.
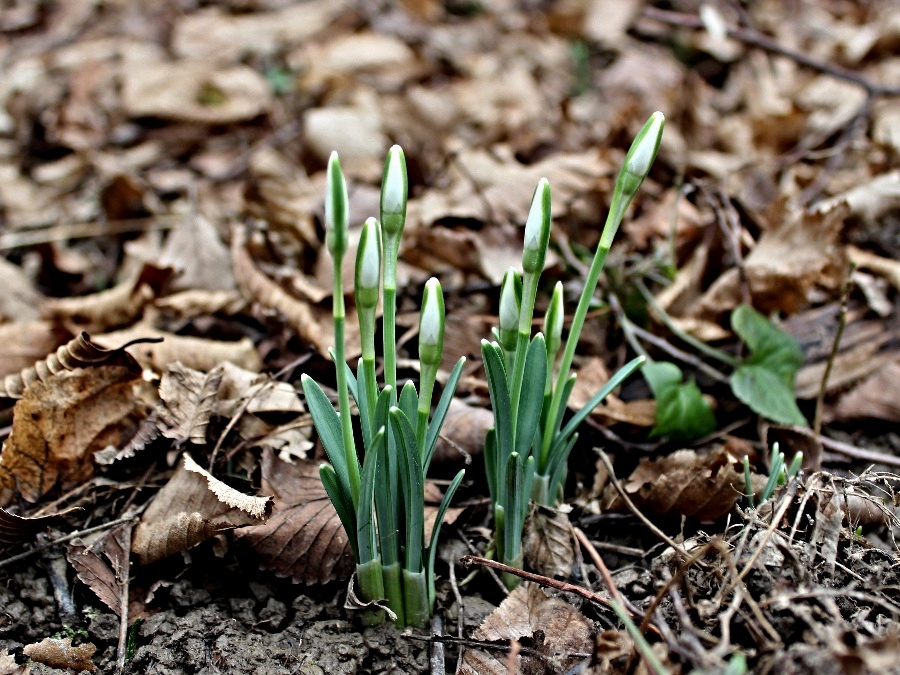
[460,582,593,675]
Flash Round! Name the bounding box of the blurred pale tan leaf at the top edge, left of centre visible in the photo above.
[172,0,347,63]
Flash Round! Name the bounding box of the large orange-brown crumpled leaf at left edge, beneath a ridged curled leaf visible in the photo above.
[0,357,149,506]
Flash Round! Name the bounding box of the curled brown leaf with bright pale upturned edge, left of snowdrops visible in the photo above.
[131,453,272,565]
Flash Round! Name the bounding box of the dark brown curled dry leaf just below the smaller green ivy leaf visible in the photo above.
[603,448,744,520]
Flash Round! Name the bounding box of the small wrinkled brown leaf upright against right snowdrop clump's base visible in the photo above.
[522,506,575,578]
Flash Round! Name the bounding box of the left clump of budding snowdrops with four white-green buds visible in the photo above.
[302,146,465,626]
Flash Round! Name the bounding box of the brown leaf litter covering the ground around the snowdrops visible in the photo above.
[0,0,900,673]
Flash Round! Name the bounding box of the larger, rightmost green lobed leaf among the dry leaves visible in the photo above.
[731,305,807,426]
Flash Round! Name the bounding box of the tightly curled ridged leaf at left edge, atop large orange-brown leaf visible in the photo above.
[0,333,158,398]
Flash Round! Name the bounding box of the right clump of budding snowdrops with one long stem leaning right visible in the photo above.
[481,112,665,587]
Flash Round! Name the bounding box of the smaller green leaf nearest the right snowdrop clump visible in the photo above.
[641,361,716,441]
